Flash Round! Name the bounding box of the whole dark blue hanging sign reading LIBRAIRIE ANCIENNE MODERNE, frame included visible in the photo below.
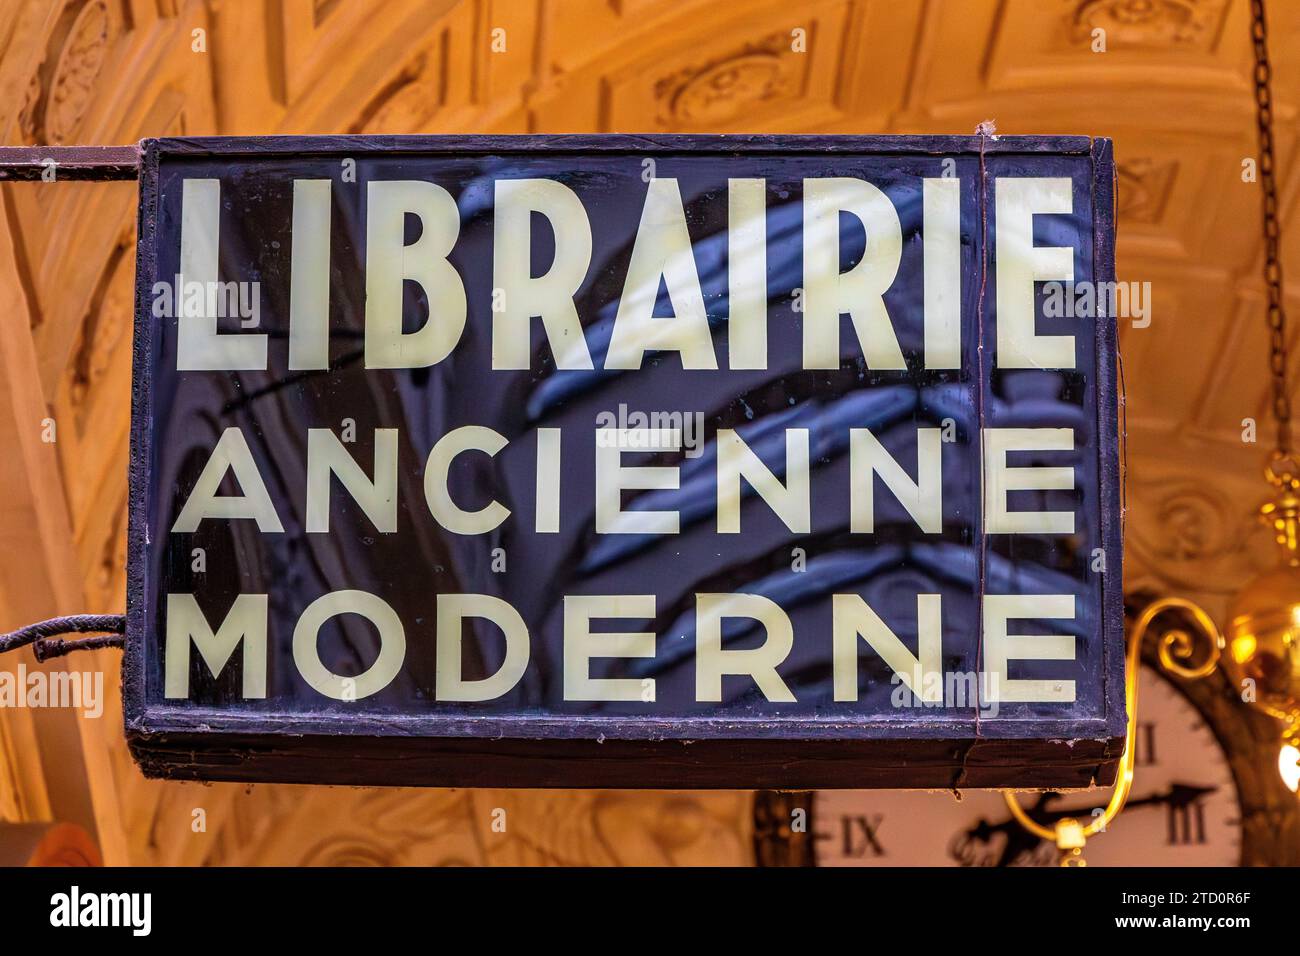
[125,137,1126,788]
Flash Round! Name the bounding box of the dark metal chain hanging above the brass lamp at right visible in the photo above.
[1251,0,1291,459]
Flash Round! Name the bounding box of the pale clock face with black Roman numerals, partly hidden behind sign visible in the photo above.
[813,667,1242,866]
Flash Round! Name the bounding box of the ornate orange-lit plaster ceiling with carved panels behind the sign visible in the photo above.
[0,0,1300,862]
